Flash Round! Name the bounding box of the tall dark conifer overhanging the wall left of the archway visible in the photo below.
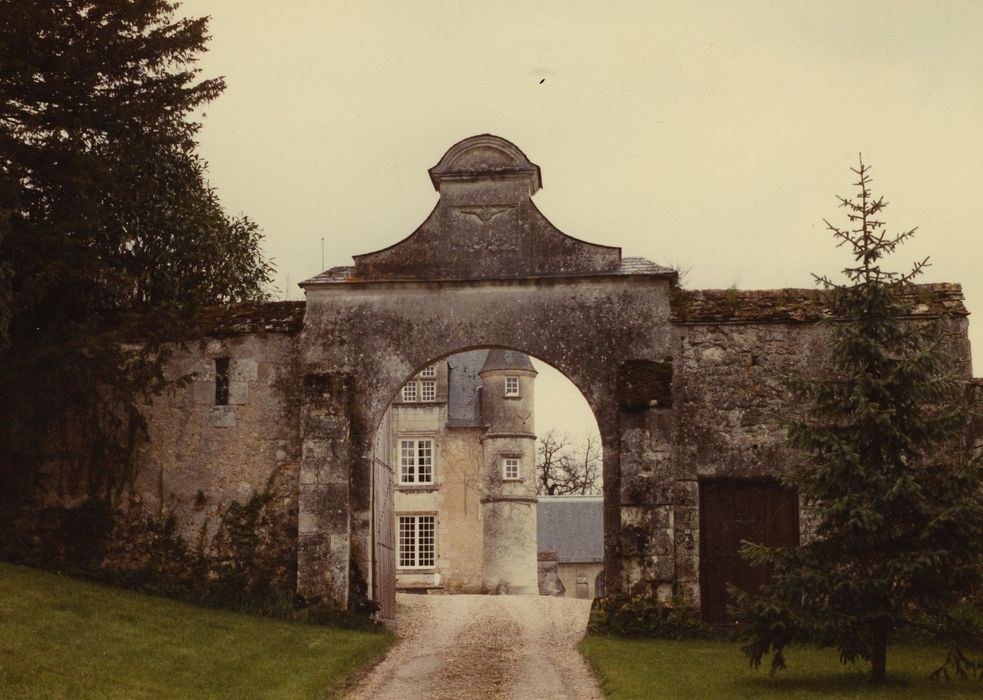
[0,0,271,498]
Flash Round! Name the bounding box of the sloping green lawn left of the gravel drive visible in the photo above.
[0,563,394,700]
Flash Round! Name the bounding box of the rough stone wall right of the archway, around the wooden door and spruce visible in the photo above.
[668,284,971,603]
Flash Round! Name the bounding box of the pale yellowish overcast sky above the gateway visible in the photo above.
[181,0,983,442]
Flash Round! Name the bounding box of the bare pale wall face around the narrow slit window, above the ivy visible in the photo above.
[133,333,300,541]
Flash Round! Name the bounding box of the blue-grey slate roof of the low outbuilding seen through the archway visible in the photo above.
[536,496,604,564]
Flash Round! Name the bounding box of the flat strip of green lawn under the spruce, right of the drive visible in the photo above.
[580,637,983,700]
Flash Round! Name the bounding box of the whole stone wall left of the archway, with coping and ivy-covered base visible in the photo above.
[0,303,304,613]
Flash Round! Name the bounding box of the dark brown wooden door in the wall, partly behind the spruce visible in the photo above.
[700,479,799,623]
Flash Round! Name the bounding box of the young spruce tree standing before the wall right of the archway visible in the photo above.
[732,159,983,683]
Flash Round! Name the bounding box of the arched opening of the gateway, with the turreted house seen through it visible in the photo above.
[368,347,604,614]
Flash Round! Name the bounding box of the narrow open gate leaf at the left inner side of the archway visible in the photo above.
[372,453,396,617]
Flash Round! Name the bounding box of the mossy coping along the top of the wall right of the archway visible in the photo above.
[670,282,969,324]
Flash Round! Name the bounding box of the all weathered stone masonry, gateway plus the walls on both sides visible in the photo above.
[28,135,971,616]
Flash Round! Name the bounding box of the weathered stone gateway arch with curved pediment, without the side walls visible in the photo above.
[297,134,676,606]
